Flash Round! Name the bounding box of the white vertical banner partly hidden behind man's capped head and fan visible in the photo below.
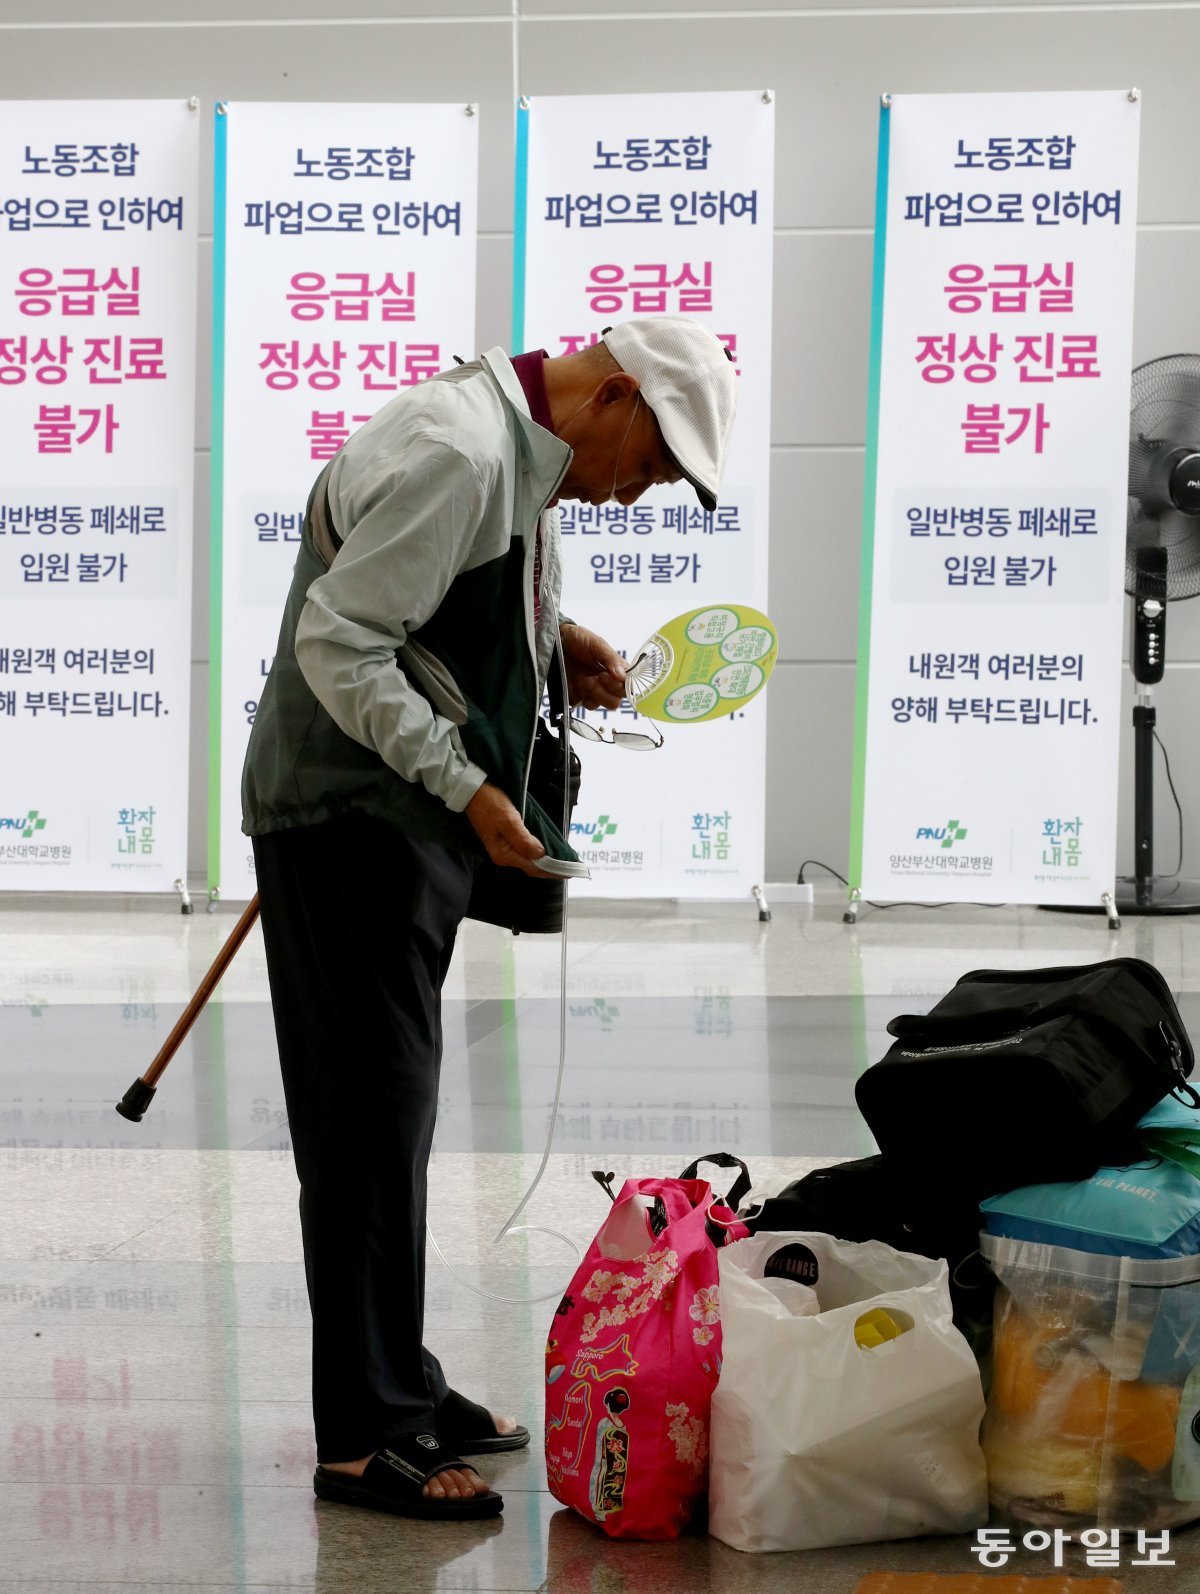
[513,89,775,897]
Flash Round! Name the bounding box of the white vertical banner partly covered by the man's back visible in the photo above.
[209,102,480,899]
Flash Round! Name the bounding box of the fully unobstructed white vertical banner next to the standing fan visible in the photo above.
[851,89,1139,905]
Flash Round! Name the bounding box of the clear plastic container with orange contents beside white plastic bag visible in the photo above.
[980,1234,1200,1529]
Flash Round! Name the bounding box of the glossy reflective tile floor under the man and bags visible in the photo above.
[0,893,1200,1594]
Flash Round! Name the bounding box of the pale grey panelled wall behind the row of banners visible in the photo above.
[0,0,1200,878]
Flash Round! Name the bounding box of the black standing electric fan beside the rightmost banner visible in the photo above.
[1116,354,1200,913]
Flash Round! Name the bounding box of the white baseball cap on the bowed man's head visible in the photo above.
[602,316,738,510]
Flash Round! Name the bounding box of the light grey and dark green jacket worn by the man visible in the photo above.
[242,349,574,858]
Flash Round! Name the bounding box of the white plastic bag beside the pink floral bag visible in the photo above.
[709,1234,988,1549]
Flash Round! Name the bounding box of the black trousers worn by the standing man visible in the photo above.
[253,815,475,1462]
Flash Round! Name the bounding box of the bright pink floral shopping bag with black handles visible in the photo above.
[545,1156,749,1538]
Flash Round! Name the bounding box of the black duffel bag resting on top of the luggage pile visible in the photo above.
[854,958,1200,1211]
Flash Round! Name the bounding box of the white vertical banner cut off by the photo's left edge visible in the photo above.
[0,100,199,891]
